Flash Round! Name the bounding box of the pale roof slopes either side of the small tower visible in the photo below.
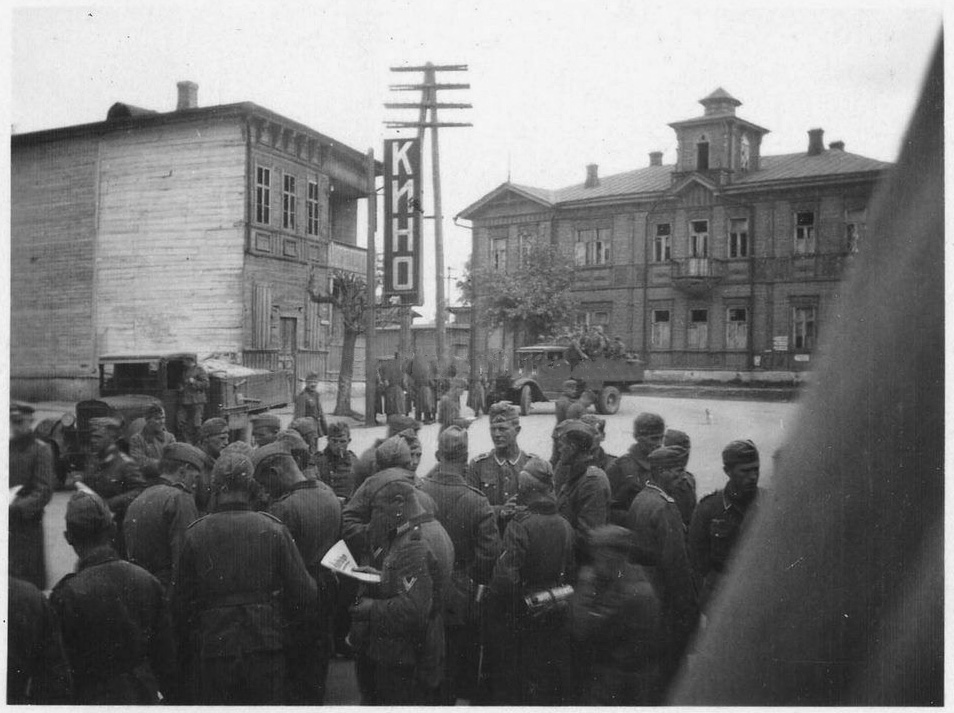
[460,149,891,218]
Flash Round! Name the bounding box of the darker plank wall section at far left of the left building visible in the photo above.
[10,138,97,400]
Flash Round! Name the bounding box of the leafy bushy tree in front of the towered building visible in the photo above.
[457,244,577,344]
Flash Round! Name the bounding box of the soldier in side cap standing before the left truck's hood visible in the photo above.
[82,417,146,557]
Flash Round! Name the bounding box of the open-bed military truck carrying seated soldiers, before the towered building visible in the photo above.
[494,344,645,416]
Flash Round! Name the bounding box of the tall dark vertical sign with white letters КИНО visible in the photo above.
[384,139,423,305]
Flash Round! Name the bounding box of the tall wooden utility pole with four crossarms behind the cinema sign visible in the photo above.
[384,62,473,365]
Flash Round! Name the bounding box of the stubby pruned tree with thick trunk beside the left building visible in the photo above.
[308,268,373,419]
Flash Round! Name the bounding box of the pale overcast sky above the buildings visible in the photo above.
[9,0,941,315]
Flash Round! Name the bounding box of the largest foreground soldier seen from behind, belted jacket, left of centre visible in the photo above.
[173,453,318,705]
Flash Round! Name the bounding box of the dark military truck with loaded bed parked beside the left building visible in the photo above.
[36,354,294,480]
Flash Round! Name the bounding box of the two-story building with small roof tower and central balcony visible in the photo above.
[460,88,890,372]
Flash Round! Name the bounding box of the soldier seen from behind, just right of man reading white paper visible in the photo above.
[420,426,500,705]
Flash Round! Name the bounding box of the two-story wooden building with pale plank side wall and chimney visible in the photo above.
[10,82,381,399]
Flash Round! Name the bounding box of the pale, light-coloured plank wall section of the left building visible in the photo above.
[96,121,246,355]
